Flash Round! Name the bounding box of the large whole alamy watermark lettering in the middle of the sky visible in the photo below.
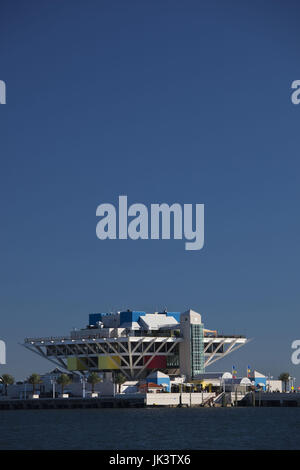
[96,196,204,250]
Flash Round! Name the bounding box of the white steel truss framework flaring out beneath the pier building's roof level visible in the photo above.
[23,335,248,379]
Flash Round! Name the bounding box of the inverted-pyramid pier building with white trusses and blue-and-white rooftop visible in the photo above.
[24,310,248,380]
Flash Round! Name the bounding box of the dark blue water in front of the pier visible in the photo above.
[0,408,300,450]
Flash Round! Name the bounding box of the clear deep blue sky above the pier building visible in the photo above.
[0,0,300,385]
